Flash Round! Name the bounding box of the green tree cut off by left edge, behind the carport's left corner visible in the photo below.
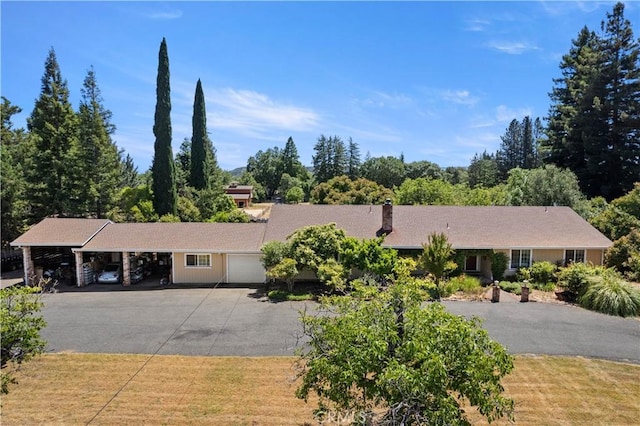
[0,96,30,243]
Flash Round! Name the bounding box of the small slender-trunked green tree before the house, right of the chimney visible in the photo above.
[418,233,458,300]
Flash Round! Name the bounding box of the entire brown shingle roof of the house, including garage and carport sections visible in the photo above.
[11,204,612,253]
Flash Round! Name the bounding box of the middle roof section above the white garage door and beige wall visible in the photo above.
[81,222,266,253]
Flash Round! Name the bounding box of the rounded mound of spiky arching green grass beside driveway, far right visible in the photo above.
[579,270,640,317]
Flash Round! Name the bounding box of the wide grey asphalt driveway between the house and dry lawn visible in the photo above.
[42,286,640,363]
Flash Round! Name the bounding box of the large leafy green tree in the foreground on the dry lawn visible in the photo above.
[296,273,514,425]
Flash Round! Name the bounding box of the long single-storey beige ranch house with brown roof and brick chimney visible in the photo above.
[12,203,612,285]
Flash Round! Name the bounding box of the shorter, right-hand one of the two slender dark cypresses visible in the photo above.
[189,79,211,189]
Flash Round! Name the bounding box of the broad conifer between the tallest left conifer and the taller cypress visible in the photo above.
[76,68,122,217]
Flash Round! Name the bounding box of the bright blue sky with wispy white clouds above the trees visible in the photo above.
[0,1,640,172]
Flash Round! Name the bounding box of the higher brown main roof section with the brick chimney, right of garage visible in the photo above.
[265,204,611,249]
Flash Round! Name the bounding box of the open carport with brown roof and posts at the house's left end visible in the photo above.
[11,218,112,285]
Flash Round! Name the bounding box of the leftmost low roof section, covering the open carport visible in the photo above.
[11,218,111,247]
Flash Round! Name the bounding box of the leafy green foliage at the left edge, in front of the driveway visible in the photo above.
[0,286,46,394]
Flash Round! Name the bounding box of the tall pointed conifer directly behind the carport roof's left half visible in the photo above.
[26,48,78,222]
